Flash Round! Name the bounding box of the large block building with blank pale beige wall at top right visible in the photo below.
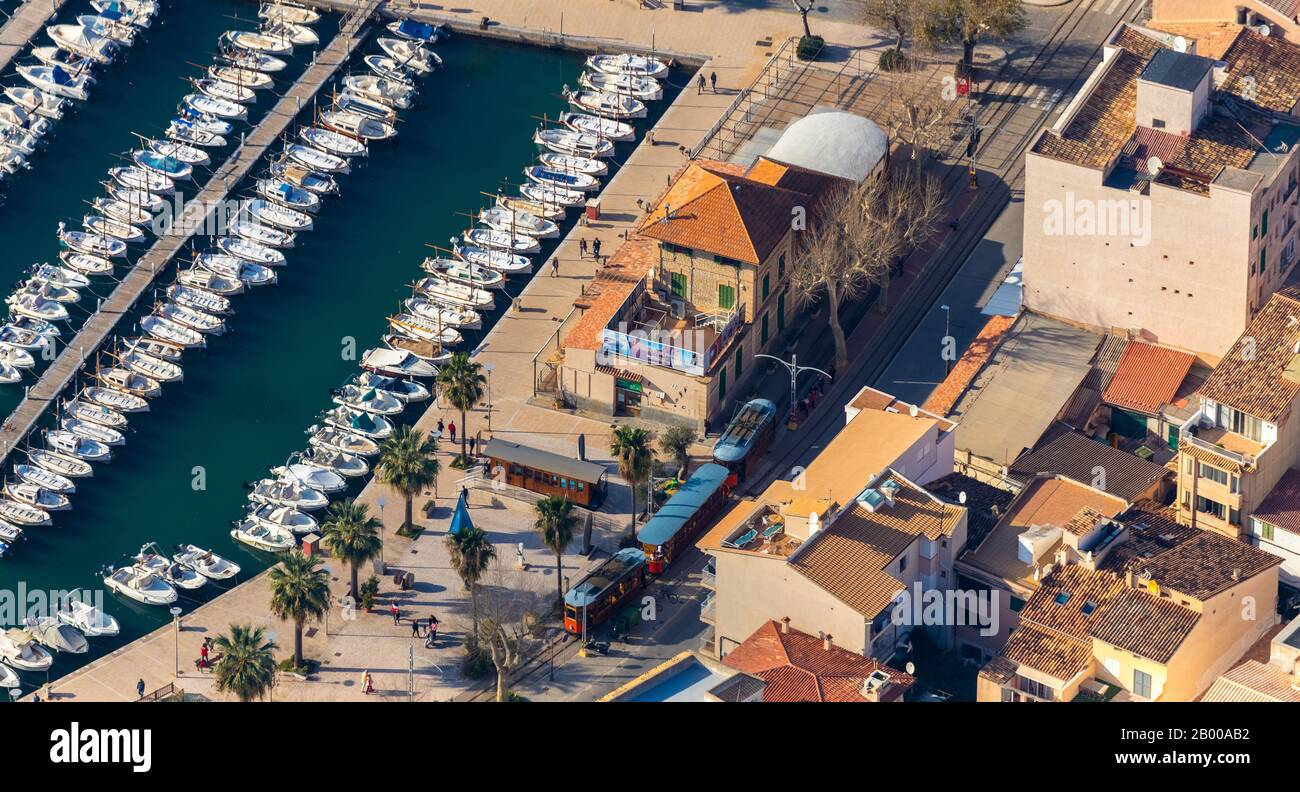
[1024,25,1300,360]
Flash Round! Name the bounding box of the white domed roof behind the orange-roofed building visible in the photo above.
[766,111,889,182]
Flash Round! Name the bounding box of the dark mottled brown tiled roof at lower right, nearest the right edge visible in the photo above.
[1143,531,1282,601]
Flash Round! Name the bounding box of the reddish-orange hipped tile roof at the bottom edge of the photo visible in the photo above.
[723,620,915,701]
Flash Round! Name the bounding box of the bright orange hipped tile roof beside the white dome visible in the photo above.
[638,161,815,264]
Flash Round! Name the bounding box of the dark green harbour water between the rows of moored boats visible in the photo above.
[0,0,667,685]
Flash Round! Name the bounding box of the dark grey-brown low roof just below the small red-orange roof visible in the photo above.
[1008,432,1169,503]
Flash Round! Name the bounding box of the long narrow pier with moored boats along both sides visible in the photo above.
[0,0,382,462]
